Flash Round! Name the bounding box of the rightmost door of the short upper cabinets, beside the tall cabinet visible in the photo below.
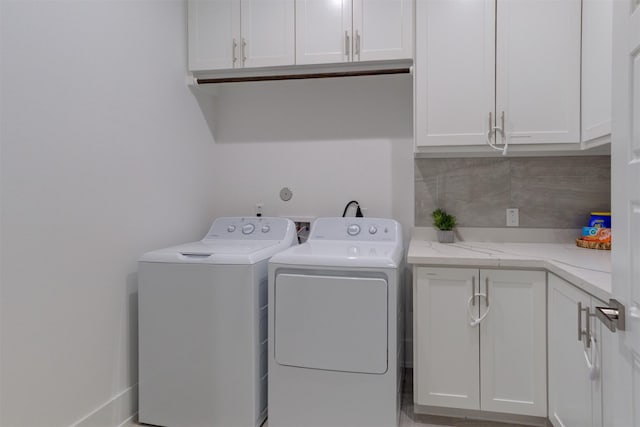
[353,0,413,61]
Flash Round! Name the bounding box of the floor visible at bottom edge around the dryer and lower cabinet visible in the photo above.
[129,370,522,427]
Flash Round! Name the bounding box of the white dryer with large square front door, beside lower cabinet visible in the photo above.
[269,218,403,427]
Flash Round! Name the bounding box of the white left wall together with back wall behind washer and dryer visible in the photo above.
[0,0,413,427]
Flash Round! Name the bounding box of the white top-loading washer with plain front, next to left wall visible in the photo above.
[138,218,297,427]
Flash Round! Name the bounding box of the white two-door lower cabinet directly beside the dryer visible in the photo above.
[414,266,547,417]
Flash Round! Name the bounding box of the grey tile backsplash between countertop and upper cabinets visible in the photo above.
[415,156,611,228]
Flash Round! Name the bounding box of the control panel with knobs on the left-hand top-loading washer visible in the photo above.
[203,217,295,240]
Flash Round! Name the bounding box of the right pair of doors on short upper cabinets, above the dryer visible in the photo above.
[296,0,413,64]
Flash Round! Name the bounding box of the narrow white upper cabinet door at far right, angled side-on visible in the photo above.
[582,0,613,142]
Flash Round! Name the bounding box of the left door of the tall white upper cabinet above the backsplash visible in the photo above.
[415,0,495,146]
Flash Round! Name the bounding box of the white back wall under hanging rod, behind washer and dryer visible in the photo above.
[196,75,414,232]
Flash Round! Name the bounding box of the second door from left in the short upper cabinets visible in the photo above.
[240,0,295,67]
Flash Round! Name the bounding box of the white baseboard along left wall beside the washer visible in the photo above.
[70,384,138,427]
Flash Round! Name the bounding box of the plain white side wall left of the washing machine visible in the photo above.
[0,0,214,427]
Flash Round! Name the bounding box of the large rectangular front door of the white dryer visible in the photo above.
[274,274,388,374]
